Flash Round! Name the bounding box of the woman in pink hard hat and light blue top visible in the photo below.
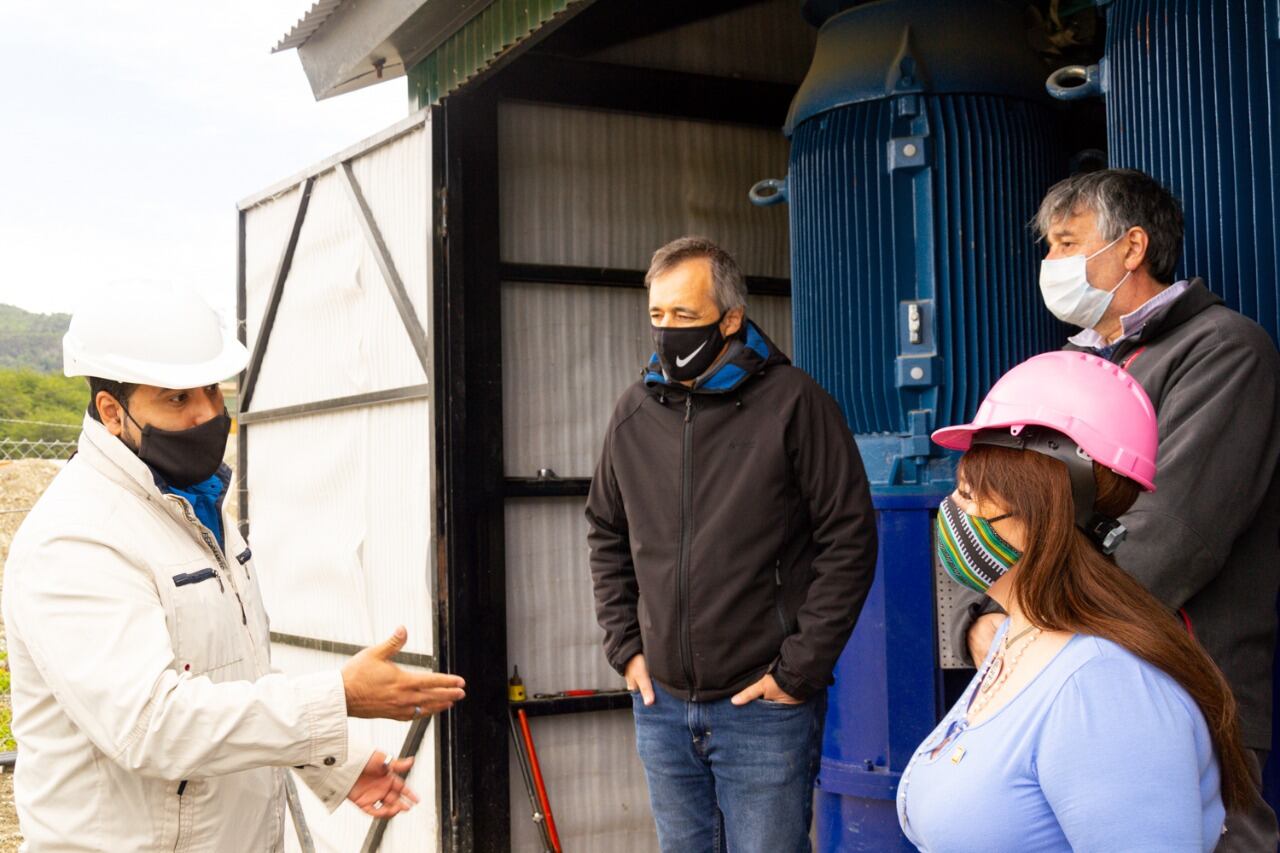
[897,352,1256,853]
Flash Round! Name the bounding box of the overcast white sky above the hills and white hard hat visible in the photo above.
[0,0,408,318]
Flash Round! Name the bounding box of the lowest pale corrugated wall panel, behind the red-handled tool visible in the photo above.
[509,711,658,853]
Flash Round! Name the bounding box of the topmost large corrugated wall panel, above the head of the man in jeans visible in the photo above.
[498,102,790,278]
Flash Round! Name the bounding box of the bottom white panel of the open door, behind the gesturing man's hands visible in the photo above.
[271,643,440,853]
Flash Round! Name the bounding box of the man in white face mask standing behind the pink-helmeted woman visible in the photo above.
[954,169,1280,850]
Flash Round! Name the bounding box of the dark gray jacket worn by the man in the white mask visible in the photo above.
[952,279,1280,749]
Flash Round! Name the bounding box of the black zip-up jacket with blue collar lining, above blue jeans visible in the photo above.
[586,324,876,701]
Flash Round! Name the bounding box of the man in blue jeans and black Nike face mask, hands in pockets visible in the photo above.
[586,238,876,853]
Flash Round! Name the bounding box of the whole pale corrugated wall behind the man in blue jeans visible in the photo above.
[499,94,791,853]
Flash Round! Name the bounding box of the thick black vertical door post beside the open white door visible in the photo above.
[433,83,511,853]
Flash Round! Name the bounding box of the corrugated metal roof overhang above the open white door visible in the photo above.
[273,0,586,105]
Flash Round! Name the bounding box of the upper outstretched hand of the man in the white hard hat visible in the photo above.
[342,625,466,720]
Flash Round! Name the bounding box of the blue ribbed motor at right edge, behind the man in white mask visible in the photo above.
[1048,0,1280,824]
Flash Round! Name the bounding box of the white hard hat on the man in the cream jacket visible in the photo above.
[63,282,248,388]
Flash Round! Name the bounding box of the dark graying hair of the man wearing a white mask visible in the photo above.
[1032,169,1183,284]
